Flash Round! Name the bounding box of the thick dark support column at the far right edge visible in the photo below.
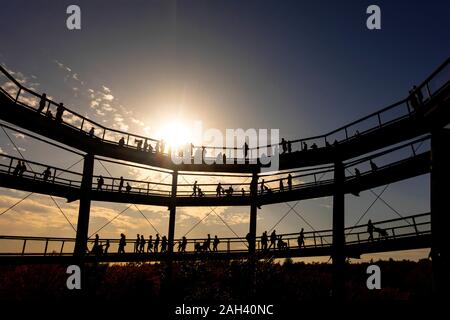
[430,129,450,297]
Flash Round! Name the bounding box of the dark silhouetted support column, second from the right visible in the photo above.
[332,161,345,299]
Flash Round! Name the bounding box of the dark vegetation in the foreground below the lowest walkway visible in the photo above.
[0,260,431,303]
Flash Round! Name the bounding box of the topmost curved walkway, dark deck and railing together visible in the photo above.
[0,59,450,173]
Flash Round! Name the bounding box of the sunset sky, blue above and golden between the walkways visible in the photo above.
[0,0,450,260]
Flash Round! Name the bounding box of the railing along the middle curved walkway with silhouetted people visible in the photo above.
[0,136,429,198]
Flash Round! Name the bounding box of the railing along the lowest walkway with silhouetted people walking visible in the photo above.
[0,213,431,257]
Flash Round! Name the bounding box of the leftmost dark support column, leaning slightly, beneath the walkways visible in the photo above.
[74,153,94,257]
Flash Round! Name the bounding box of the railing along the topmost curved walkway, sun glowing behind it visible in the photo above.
[0,58,450,163]
